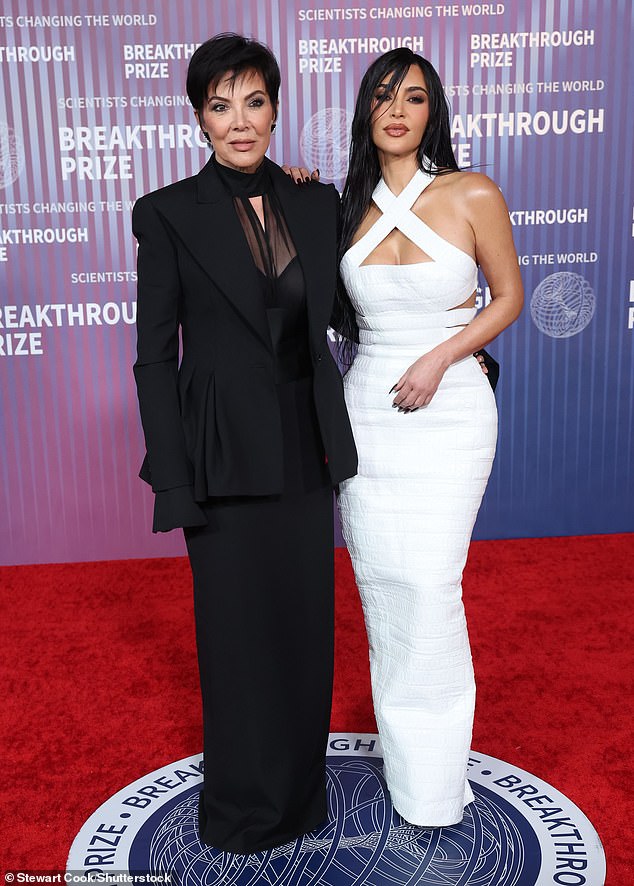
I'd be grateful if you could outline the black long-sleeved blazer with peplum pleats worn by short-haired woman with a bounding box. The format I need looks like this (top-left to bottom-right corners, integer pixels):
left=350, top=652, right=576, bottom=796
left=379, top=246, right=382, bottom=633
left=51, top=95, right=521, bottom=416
left=132, top=159, right=357, bottom=531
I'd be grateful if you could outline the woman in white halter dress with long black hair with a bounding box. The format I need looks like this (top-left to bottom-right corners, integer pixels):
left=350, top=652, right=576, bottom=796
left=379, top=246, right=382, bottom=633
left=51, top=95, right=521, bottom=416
left=337, top=49, right=523, bottom=827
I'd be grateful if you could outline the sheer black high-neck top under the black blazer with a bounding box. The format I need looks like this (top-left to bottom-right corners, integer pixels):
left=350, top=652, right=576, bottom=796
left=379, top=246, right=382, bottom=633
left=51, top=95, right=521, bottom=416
left=214, top=157, right=312, bottom=384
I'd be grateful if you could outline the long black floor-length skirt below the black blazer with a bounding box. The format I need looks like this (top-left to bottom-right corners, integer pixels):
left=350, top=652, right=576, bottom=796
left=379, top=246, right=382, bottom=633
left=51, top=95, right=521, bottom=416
left=185, top=379, right=334, bottom=853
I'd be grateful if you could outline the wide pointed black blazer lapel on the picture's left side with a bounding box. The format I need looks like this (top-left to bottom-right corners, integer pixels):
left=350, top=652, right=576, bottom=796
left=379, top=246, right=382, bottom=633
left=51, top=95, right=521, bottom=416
left=159, top=161, right=271, bottom=348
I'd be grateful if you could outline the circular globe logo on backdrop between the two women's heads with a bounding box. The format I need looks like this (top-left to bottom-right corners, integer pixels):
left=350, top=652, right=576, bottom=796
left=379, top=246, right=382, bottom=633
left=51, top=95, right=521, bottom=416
left=299, top=108, right=352, bottom=179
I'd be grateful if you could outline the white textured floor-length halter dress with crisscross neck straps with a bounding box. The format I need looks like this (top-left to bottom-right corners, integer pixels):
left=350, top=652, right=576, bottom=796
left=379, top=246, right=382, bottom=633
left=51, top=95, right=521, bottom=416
left=338, top=171, right=497, bottom=826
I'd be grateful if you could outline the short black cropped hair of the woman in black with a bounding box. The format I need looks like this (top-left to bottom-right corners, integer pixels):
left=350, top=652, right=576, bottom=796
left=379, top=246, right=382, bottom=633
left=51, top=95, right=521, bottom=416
left=187, top=33, right=281, bottom=111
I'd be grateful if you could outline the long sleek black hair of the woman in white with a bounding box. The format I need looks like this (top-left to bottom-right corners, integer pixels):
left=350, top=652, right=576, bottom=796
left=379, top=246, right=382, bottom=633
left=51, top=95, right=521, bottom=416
left=335, top=47, right=459, bottom=366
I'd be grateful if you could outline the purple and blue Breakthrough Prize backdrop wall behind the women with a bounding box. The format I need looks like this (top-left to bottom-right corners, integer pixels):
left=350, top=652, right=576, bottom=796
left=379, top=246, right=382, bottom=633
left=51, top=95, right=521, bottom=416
left=0, top=0, right=634, bottom=563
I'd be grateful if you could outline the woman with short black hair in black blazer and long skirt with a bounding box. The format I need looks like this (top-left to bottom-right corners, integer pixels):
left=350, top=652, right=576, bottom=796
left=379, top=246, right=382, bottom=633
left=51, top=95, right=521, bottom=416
left=133, top=34, right=357, bottom=853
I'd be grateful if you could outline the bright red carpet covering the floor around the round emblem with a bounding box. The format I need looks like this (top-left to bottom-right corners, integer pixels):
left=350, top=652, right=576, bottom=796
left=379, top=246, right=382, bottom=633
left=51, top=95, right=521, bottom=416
left=0, top=535, right=634, bottom=886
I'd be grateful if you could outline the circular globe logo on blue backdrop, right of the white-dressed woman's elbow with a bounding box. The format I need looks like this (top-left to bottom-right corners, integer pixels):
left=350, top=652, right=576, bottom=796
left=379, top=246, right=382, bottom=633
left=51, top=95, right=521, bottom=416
left=531, top=271, right=596, bottom=338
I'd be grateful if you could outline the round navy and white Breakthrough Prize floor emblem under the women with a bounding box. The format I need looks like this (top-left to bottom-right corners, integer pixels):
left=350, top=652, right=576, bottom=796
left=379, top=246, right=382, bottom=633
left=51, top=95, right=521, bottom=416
left=67, top=733, right=605, bottom=886
